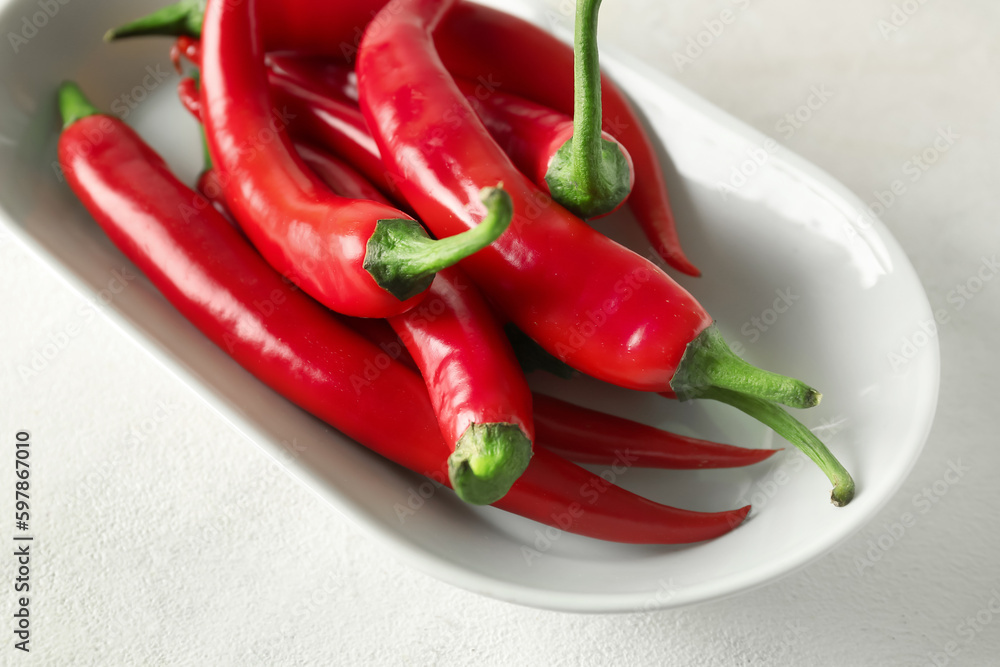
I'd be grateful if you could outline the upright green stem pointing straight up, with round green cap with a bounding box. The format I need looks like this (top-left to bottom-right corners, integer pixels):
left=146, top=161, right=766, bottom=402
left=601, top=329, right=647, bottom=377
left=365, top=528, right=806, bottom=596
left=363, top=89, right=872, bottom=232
left=545, top=0, right=632, bottom=219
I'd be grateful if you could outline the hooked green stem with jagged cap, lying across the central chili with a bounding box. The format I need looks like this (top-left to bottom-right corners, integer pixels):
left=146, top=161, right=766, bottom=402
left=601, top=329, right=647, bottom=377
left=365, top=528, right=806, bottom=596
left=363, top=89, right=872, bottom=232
left=364, top=185, right=514, bottom=301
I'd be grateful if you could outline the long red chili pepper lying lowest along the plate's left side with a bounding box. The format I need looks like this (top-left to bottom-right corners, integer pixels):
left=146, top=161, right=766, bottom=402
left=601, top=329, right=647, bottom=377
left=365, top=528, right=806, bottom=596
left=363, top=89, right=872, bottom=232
left=59, top=84, right=750, bottom=544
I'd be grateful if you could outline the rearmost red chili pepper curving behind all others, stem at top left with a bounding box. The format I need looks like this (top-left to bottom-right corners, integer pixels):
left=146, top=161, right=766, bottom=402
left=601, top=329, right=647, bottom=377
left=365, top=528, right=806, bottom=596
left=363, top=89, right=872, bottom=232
left=106, top=0, right=700, bottom=276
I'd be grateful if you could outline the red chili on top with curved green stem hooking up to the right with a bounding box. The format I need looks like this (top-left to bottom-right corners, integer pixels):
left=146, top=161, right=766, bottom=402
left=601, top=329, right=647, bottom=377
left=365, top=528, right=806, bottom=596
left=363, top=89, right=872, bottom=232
left=194, top=1, right=508, bottom=317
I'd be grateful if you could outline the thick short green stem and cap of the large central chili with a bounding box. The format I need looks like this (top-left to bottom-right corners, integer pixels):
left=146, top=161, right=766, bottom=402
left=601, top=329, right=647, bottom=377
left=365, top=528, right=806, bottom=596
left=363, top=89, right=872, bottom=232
left=670, top=322, right=823, bottom=408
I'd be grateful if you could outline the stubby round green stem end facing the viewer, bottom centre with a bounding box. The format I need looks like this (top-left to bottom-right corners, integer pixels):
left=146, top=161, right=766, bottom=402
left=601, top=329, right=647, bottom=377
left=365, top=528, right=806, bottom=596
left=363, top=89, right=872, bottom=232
left=448, top=423, right=531, bottom=505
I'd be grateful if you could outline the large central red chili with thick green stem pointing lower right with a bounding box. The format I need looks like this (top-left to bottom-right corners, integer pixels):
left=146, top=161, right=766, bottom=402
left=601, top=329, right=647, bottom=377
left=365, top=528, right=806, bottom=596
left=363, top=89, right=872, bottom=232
left=357, top=0, right=854, bottom=505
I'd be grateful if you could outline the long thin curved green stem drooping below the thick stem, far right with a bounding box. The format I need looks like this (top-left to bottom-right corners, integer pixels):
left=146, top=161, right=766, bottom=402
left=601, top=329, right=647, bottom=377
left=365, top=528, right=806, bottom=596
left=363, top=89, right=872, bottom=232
left=702, top=388, right=854, bottom=507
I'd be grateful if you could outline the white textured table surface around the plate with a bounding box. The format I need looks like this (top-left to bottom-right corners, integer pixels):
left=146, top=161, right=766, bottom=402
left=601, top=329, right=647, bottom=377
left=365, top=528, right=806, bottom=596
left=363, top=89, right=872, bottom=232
left=0, top=0, right=1000, bottom=665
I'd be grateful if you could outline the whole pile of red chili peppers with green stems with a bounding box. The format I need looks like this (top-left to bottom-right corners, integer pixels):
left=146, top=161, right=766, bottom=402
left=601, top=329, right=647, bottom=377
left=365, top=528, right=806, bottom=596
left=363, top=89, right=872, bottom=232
left=52, top=0, right=854, bottom=544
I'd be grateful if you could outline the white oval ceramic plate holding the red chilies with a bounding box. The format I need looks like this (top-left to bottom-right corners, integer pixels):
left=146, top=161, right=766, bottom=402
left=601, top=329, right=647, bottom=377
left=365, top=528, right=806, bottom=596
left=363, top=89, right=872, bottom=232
left=0, top=0, right=938, bottom=611
